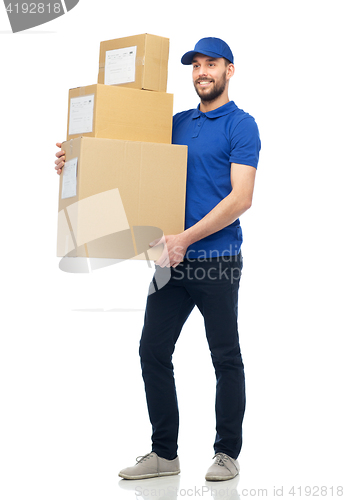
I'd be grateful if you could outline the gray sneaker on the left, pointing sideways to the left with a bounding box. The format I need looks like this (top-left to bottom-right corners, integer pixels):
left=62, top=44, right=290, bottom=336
left=119, top=451, right=180, bottom=479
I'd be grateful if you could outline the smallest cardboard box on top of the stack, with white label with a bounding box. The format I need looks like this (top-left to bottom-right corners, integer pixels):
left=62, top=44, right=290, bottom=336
left=98, top=33, right=169, bottom=92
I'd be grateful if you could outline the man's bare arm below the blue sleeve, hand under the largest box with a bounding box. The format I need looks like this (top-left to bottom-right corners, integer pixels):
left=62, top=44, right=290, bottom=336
left=152, top=163, right=256, bottom=267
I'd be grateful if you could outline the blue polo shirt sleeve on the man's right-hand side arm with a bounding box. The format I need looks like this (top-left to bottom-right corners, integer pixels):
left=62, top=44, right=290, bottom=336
left=229, top=115, right=261, bottom=168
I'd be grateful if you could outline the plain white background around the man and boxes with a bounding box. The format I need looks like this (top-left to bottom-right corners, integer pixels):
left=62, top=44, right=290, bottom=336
left=0, top=0, right=345, bottom=500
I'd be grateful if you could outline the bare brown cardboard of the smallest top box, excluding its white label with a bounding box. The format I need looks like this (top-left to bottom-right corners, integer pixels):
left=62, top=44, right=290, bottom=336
left=98, top=33, right=169, bottom=92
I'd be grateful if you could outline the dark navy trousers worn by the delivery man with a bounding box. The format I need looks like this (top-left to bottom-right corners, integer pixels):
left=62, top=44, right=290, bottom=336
left=139, top=253, right=245, bottom=460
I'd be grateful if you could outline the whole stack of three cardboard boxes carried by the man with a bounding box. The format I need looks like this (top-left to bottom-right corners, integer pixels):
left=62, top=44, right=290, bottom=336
left=58, top=34, right=187, bottom=260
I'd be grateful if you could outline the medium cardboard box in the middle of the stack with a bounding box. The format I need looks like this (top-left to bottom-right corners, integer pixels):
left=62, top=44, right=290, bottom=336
left=67, top=84, right=173, bottom=144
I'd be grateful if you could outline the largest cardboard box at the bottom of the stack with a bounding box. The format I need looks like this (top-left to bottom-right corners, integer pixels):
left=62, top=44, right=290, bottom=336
left=57, top=137, right=187, bottom=260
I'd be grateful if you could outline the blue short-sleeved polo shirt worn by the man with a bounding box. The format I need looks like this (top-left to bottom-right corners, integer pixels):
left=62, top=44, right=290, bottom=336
left=172, top=101, right=261, bottom=259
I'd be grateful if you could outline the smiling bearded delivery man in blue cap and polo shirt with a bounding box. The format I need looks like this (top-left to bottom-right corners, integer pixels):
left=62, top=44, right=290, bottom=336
left=55, top=37, right=261, bottom=481
